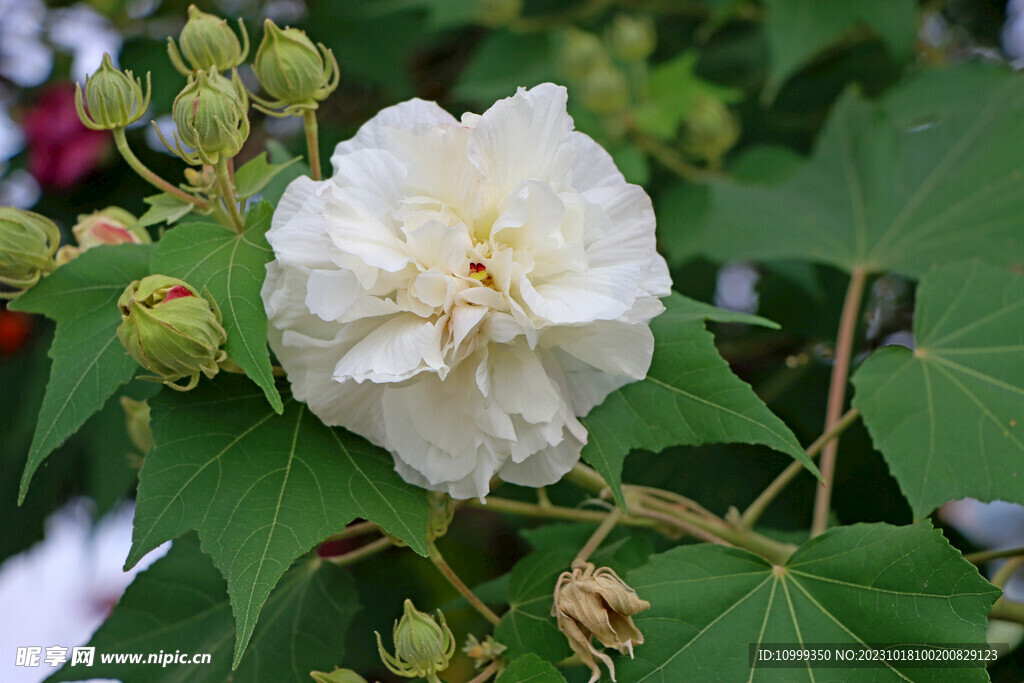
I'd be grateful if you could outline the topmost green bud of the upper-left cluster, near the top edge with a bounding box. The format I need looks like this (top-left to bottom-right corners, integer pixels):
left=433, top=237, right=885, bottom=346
left=167, top=5, right=249, bottom=76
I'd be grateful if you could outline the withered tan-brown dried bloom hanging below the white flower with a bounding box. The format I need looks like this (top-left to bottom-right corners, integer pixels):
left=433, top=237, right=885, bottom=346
left=551, top=562, right=650, bottom=683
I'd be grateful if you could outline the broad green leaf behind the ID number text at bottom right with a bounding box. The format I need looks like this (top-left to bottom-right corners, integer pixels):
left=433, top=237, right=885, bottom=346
left=612, top=521, right=999, bottom=683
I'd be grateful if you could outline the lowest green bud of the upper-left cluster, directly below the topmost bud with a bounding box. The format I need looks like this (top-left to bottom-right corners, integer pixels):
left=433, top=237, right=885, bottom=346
left=171, top=71, right=249, bottom=166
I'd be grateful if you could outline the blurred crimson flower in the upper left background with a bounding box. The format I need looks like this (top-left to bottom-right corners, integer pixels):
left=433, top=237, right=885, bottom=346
left=23, top=83, right=111, bottom=189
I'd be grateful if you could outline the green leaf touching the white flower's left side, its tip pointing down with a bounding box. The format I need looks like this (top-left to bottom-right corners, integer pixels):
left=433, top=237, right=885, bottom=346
left=153, top=202, right=283, bottom=413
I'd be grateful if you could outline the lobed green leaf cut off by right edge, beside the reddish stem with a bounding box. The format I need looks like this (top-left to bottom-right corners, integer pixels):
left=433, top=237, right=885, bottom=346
left=853, top=263, right=1024, bottom=517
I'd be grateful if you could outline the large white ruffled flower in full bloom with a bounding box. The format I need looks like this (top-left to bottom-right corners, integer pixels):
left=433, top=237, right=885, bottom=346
left=263, top=84, right=671, bottom=498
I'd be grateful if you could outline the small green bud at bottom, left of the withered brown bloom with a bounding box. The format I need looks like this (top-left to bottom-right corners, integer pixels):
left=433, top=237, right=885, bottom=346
left=377, top=600, right=455, bottom=678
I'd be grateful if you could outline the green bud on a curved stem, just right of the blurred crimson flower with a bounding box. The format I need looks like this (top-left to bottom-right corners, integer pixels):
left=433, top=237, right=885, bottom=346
left=75, top=54, right=152, bottom=130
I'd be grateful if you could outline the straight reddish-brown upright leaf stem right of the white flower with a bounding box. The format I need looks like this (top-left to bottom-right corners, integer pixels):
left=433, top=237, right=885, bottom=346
left=811, top=266, right=867, bottom=539
